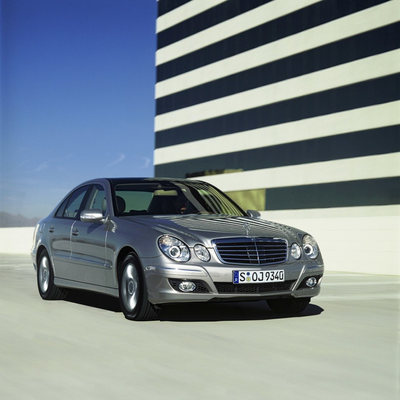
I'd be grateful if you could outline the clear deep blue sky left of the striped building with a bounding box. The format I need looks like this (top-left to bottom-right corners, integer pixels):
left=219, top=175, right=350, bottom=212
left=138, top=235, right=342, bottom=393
left=0, top=0, right=157, bottom=217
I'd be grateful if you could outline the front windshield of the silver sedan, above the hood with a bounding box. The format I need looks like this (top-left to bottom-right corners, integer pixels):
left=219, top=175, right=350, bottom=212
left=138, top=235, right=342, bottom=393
left=113, top=182, right=245, bottom=216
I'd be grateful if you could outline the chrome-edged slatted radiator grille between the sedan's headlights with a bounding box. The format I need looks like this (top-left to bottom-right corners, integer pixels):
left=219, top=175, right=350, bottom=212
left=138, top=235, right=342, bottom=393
left=213, top=238, right=287, bottom=265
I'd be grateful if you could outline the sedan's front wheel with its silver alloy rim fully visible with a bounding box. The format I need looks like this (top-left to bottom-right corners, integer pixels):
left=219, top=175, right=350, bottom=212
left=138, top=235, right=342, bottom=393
left=118, top=253, right=157, bottom=321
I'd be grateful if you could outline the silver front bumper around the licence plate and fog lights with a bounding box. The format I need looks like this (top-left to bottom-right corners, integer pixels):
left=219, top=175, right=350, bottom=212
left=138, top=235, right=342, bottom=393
left=142, top=259, right=324, bottom=304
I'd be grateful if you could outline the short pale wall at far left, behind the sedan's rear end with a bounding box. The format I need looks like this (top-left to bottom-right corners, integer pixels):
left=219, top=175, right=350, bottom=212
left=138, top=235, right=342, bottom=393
left=0, top=227, right=35, bottom=254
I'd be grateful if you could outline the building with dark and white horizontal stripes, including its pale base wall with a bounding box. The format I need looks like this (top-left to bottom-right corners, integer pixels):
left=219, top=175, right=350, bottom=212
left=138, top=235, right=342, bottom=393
left=154, top=0, right=400, bottom=274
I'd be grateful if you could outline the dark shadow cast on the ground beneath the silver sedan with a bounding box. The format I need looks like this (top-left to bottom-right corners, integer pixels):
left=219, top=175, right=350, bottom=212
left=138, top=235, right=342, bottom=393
left=66, top=290, right=324, bottom=322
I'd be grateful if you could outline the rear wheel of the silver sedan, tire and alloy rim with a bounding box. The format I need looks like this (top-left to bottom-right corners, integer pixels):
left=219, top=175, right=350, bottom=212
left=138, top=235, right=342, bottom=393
left=37, top=250, right=68, bottom=300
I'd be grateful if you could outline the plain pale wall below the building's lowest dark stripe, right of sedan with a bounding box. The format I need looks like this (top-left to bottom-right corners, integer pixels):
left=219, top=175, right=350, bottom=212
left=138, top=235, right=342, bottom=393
left=261, top=206, right=400, bottom=275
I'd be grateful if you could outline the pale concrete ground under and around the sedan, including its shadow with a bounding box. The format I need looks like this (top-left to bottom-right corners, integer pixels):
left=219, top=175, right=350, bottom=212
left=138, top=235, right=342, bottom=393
left=0, top=254, right=400, bottom=400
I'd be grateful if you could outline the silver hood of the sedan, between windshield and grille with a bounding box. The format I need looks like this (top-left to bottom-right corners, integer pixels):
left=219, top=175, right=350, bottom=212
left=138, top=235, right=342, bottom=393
left=122, top=215, right=304, bottom=246
